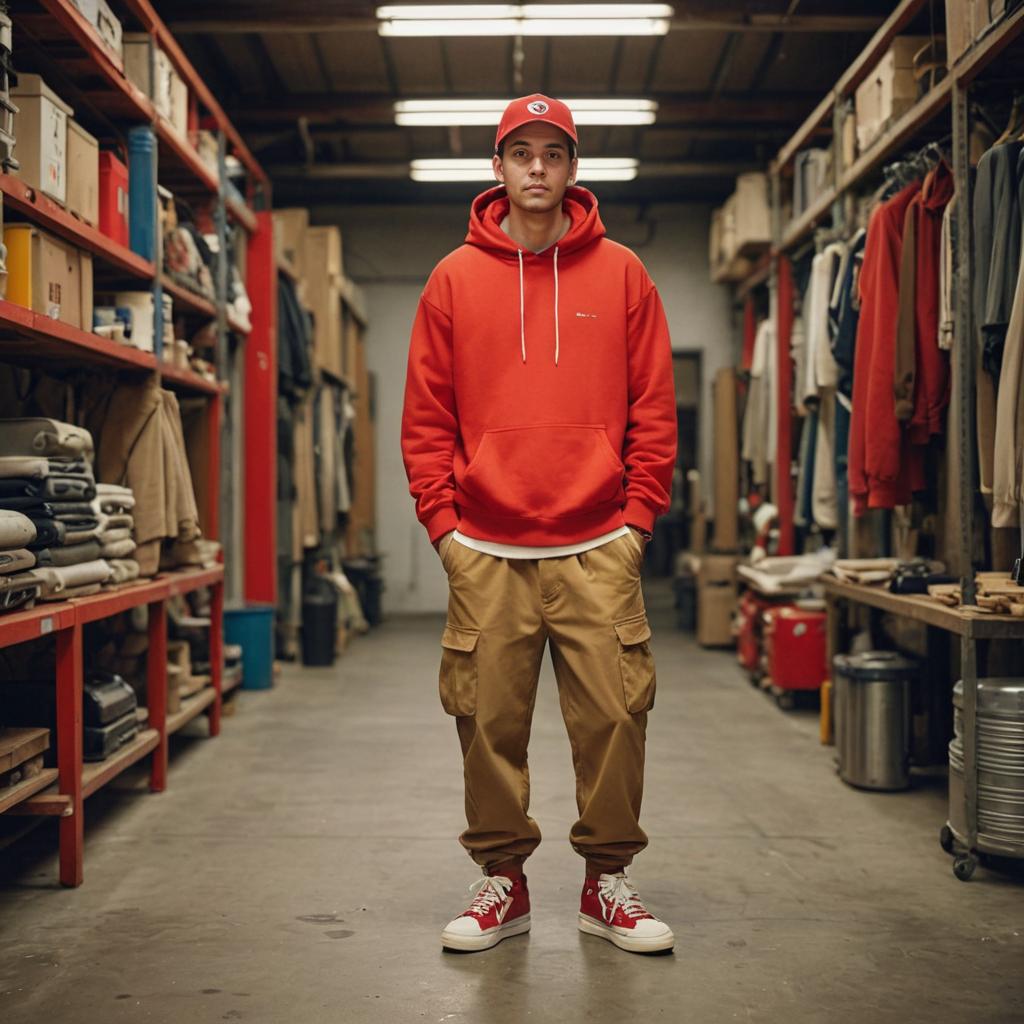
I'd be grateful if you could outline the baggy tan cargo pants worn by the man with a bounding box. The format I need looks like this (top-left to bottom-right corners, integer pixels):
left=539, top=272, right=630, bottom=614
left=440, top=532, right=655, bottom=874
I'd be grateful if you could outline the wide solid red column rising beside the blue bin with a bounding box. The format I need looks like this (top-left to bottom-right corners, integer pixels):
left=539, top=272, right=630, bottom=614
left=244, top=210, right=278, bottom=604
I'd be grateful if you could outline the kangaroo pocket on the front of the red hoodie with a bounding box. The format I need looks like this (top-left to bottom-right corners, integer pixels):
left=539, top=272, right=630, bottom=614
left=461, top=423, right=625, bottom=519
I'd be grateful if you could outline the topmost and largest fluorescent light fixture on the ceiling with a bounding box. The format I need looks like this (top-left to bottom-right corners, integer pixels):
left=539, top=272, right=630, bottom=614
left=377, top=3, right=673, bottom=36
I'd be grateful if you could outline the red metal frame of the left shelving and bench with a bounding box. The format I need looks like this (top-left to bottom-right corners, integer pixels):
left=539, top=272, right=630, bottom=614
left=0, top=0, right=276, bottom=886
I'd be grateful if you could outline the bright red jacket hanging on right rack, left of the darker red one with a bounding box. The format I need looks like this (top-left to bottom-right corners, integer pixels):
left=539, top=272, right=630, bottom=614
left=849, top=181, right=925, bottom=516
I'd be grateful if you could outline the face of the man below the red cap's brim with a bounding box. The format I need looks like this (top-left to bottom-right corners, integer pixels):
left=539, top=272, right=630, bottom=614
left=494, top=121, right=577, bottom=213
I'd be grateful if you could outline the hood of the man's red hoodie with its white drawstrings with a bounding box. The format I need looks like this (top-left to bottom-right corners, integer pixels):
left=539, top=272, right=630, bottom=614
left=466, top=185, right=604, bottom=367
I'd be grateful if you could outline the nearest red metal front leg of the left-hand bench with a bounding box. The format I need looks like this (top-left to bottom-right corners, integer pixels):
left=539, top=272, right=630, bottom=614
left=56, top=623, right=85, bottom=886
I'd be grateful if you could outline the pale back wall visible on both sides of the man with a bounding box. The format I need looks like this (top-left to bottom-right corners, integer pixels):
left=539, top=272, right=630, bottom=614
left=313, top=204, right=736, bottom=612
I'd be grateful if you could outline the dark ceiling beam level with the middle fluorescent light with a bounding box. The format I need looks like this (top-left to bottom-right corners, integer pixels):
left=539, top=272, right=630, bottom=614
left=230, top=93, right=811, bottom=127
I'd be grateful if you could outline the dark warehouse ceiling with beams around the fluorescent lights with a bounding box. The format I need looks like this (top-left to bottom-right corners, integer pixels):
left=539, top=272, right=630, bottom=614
left=156, top=0, right=905, bottom=205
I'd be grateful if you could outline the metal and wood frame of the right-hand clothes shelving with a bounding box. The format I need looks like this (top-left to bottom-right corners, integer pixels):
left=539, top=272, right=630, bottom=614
left=770, top=0, right=1024, bottom=881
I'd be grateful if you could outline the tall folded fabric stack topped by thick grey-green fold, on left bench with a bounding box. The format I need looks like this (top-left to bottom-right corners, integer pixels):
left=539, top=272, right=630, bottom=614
left=0, top=417, right=111, bottom=601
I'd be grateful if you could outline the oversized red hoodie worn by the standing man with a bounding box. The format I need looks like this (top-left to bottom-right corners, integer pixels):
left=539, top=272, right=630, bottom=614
left=401, top=186, right=676, bottom=546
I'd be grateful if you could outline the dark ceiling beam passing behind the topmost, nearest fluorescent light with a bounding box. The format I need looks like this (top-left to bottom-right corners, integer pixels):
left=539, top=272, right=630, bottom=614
left=169, top=12, right=883, bottom=36
